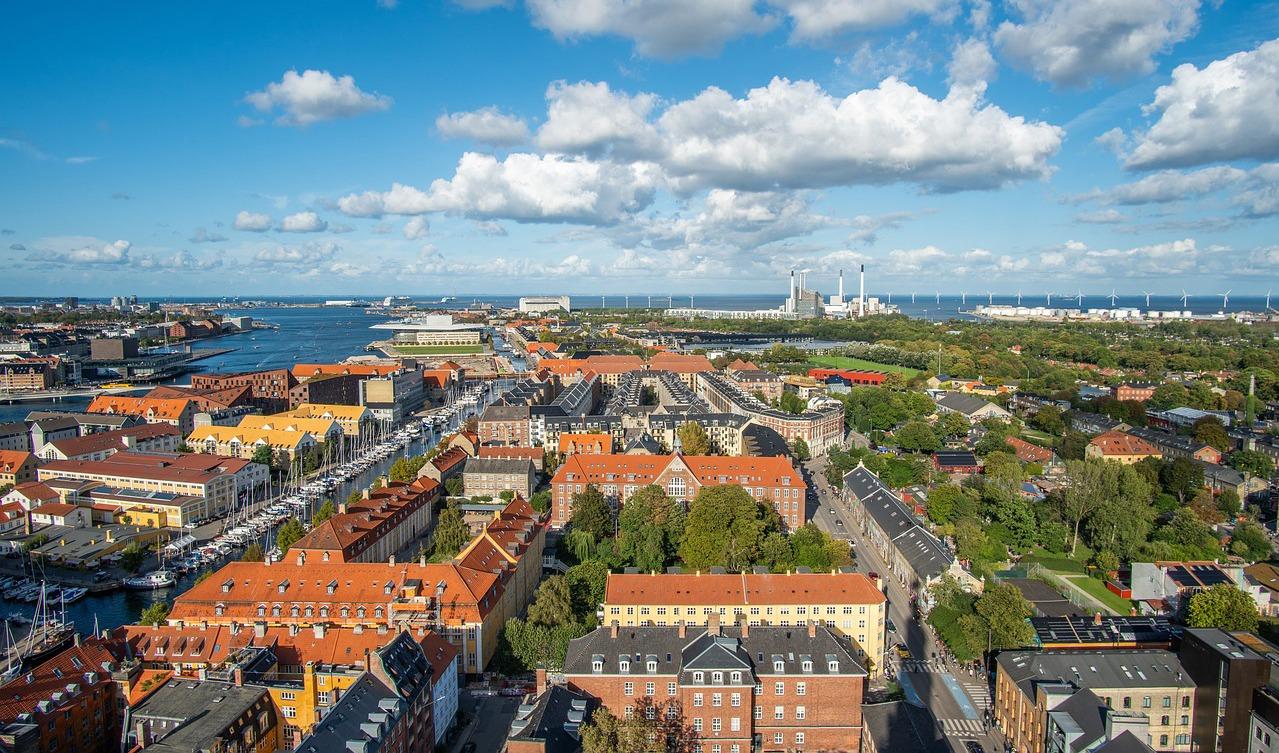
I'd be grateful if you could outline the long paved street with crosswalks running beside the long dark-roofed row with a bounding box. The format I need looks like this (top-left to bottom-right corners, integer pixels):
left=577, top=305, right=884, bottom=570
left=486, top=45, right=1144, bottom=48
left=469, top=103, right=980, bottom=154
left=806, top=458, right=1003, bottom=753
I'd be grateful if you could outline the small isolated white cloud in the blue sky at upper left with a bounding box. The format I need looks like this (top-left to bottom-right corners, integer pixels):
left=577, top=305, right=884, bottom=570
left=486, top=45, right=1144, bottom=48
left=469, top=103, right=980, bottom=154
left=244, top=70, right=391, bottom=127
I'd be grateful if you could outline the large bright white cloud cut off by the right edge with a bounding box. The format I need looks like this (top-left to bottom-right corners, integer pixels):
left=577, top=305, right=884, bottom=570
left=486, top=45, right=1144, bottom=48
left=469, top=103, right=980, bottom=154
left=1124, top=40, right=1279, bottom=169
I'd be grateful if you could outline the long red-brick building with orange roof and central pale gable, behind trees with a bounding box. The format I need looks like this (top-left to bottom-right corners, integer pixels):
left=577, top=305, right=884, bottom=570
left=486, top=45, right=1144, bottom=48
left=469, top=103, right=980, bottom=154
left=551, top=454, right=808, bottom=531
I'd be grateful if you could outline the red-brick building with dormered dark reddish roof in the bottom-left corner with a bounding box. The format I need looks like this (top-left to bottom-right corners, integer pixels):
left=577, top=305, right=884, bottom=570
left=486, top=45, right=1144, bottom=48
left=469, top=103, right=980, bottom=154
left=0, top=638, right=123, bottom=753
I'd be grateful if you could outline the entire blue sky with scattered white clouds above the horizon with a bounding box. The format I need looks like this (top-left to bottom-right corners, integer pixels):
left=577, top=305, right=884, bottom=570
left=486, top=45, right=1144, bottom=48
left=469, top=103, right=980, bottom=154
left=0, top=0, right=1279, bottom=295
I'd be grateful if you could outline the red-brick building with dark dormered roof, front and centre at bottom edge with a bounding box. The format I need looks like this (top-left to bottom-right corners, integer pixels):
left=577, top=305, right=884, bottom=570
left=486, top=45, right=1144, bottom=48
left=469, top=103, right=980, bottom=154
left=564, top=615, right=866, bottom=753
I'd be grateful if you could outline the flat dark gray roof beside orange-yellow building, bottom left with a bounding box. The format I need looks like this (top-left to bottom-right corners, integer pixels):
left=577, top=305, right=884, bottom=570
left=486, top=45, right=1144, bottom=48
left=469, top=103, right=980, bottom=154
left=130, top=679, right=266, bottom=753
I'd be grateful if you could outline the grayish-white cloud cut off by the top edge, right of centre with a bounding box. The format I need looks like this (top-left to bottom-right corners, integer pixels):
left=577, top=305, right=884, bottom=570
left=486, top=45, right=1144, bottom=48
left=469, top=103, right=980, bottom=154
left=995, top=0, right=1200, bottom=87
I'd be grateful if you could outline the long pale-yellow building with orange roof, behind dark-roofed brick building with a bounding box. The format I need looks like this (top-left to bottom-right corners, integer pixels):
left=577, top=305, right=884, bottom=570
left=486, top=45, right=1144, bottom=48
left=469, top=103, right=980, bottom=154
left=600, top=571, right=888, bottom=676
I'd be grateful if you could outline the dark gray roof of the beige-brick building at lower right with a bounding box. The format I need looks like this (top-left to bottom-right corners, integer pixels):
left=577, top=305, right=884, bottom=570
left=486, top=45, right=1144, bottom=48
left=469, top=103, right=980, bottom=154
left=995, top=648, right=1195, bottom=698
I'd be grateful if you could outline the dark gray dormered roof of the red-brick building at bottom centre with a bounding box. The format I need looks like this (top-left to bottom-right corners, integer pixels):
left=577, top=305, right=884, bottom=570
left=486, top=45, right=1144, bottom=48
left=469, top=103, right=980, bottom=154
left=564, top=626, right=866, bottom=681
